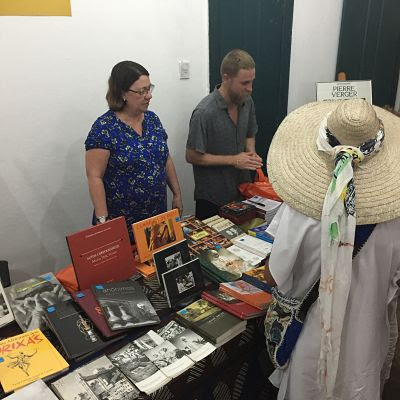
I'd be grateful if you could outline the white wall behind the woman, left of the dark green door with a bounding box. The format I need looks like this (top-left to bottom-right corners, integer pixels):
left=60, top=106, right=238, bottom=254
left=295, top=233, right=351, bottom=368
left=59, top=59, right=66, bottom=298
left=0, top=0, right=208, bottom=281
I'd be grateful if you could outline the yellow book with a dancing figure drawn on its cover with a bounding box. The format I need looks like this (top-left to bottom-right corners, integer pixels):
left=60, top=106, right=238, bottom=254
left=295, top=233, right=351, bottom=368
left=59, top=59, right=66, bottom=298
left=0, top=329, right=69, bottom=393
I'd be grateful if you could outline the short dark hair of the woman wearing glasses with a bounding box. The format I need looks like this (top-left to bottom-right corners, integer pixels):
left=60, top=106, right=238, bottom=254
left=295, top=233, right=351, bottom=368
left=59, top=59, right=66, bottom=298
left=106, top=61, right=149, bottom=111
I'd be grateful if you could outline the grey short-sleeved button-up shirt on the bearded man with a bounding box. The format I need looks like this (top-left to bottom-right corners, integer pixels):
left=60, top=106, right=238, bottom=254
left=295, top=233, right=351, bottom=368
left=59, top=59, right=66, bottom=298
left=186, top=87, right=258, bottom=206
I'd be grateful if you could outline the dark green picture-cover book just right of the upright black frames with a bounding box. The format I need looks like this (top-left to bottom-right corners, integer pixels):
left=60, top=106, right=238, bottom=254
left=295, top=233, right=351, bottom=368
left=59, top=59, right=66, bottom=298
left=199, top=247, right=252, bottom=282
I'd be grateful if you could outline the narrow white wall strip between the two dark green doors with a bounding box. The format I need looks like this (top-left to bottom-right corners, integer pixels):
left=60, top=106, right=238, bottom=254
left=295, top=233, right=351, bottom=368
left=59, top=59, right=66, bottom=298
left=288, top=0, right=343, bottom=112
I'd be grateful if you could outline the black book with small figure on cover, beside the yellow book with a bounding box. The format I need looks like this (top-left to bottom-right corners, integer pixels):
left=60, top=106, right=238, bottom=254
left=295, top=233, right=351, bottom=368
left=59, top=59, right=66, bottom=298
left=45, top=300, right=111, bottom=359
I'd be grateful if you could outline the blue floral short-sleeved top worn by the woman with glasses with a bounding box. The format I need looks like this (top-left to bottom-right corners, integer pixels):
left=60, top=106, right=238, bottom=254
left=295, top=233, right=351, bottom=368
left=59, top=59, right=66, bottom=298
left=85, top=110, right=169, bottom=240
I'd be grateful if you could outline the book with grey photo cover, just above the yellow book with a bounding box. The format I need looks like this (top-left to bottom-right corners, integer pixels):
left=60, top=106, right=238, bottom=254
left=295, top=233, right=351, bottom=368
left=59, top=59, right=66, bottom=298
left=4, top=272, right=71, bottom=332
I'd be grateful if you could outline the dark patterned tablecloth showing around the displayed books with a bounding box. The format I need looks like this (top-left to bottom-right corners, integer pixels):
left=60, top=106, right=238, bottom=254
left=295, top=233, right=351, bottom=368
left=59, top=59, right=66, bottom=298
left=0, top=280, right=276, bottom=400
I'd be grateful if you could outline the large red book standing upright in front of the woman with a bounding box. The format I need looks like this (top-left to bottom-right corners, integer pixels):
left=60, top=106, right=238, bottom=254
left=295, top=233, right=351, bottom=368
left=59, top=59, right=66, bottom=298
left=67, top=217, right=136, bottom=290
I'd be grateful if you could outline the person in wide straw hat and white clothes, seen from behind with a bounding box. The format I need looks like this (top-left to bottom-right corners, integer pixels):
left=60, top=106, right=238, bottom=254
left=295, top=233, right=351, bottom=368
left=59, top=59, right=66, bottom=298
left=267, top=99, right=400, bottom=400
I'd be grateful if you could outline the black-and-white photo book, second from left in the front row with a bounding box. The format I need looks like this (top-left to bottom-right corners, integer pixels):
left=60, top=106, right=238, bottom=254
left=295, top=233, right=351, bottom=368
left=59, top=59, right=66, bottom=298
left=108, top=343, right=171, bottom=394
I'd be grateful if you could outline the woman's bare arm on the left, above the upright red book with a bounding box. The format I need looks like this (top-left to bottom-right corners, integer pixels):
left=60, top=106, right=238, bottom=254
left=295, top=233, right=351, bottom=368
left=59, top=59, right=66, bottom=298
left=85, top=149, right=110, bottom=217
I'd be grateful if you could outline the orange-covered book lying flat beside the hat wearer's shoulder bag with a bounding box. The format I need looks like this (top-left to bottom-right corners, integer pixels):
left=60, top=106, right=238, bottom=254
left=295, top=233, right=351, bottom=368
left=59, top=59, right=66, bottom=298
left=219, top=280, right=271, bottom=310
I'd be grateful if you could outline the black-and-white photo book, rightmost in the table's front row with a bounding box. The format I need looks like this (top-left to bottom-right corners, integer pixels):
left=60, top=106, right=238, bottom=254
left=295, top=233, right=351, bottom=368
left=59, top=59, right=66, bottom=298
left=157, top=321, right=216, bottom=362
